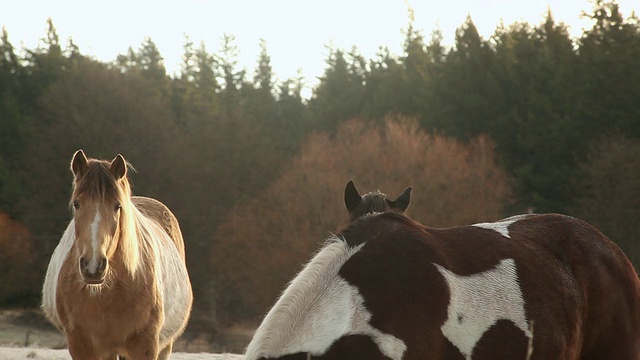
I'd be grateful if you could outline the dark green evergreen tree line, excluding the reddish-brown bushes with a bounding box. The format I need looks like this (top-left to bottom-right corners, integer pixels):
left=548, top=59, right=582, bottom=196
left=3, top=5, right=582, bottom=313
left=0, top=0, right=640, bottom=325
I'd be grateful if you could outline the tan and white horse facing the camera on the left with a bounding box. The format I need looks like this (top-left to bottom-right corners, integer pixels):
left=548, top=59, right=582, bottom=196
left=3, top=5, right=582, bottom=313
left=42, top=150, right=193, bottom=360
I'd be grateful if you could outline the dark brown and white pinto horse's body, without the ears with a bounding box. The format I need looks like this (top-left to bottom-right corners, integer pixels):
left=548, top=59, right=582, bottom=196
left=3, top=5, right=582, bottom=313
left=245, top=211, right=640, bottom=360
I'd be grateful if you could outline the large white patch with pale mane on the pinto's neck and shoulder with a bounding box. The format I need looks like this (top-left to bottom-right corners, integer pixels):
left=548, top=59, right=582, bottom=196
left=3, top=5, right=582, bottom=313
left=245, top=238, right=407, bottom=360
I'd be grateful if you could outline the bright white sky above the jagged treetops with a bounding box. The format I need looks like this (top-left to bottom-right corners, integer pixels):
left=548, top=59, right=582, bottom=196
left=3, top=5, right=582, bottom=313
left=0, top=0, right=640, bottom=95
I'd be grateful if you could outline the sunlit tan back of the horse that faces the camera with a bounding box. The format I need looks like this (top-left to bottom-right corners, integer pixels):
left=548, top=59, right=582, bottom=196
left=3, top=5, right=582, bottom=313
left=131, top=196, right=186, bottom=261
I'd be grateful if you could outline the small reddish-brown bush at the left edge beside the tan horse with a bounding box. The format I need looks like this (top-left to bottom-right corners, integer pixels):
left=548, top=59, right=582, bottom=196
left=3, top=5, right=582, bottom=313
left=0, top=212, right=40, bottom=306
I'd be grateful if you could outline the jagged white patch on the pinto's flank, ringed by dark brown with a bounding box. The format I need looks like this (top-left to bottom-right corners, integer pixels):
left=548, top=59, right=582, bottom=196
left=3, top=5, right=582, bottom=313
left=434, top=259, right=533, bottom=360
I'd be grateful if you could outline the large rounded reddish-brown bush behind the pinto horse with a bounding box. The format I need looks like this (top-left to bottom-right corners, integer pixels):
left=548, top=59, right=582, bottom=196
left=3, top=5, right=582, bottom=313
left=213, top=117, right=511, bottom=322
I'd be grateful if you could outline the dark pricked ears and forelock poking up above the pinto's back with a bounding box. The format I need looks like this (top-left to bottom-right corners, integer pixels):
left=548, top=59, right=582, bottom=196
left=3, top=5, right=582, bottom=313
left=344, top=180, right=411, bottom=222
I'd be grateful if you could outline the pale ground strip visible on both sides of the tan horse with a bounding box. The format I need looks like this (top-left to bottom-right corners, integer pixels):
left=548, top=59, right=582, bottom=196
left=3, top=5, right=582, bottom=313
left=0, top=310, right=245, bottom=360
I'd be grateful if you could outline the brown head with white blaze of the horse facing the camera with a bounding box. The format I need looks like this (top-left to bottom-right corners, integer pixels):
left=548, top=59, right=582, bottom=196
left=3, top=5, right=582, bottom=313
left=71, top=150, right=131, bottom=285
